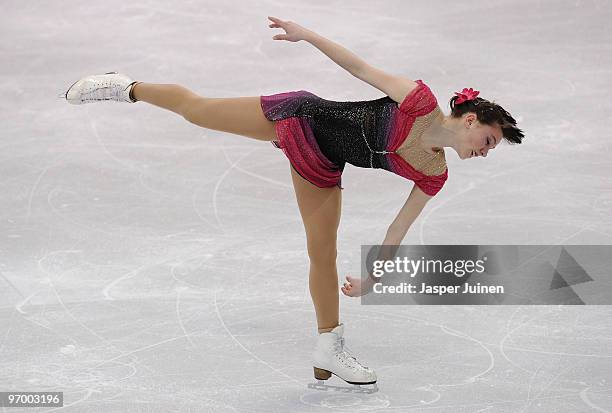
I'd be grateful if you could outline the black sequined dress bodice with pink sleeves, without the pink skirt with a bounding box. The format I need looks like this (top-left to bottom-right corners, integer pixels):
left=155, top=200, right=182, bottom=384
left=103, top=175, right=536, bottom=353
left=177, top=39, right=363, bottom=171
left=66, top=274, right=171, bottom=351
left=265, top=80, right=448, bottom=195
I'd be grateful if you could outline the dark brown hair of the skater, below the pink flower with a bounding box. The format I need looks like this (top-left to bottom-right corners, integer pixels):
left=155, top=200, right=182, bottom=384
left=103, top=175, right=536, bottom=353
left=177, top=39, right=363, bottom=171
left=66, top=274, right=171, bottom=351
left=449, top=96, right=525, bottom=144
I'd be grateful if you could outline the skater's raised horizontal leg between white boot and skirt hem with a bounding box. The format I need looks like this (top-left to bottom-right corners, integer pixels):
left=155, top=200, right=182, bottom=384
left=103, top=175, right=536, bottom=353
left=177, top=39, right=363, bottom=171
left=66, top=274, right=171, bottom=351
left=132, top=83, right=276, bottom=141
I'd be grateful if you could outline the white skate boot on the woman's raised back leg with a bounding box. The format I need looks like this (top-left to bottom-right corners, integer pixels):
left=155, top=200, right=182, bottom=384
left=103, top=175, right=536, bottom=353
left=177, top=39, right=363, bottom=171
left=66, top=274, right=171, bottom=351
left=59, top=72, right=139, bottom=105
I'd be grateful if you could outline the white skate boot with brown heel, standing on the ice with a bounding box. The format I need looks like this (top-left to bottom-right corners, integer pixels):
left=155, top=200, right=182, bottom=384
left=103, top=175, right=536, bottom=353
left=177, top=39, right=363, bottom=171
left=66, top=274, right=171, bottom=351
left=312, top=323, right=376, bottom=384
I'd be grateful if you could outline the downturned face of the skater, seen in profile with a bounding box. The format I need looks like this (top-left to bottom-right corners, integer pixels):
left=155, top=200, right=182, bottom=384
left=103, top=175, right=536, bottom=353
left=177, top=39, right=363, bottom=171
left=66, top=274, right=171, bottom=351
left=458, top=113, right=503, bottom=159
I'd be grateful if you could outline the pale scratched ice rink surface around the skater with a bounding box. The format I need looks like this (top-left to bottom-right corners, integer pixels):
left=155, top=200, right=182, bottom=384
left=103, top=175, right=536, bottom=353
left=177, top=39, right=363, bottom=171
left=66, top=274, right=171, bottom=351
left=0, top=0, right=612, bottom=413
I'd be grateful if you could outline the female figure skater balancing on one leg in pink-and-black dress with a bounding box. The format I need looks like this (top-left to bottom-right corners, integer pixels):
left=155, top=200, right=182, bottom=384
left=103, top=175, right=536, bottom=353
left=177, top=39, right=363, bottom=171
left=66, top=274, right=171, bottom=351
left=62, top=17, right=524, bottom=384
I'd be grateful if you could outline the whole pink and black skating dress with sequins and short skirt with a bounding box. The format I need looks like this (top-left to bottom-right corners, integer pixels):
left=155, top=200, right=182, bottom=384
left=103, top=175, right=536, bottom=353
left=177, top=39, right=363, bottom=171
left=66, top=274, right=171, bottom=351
left=261, top=80, right=448, bottom=195
